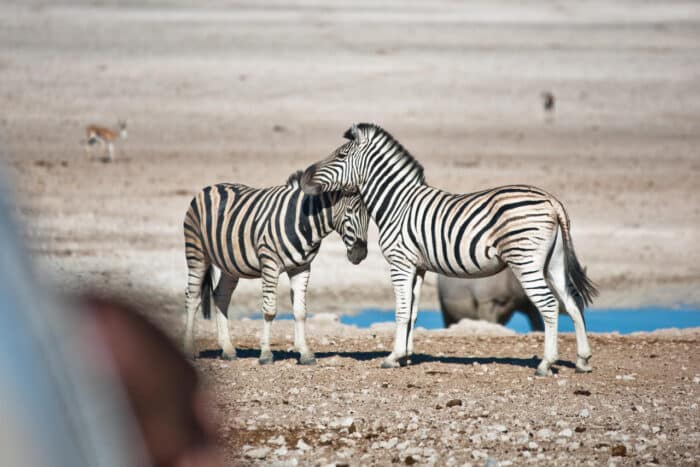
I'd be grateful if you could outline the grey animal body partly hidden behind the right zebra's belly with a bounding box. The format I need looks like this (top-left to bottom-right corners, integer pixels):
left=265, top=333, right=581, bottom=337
left=438, top=268, right=544, bottom=331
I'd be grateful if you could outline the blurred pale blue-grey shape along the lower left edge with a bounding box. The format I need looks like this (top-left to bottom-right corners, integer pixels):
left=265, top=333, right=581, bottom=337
left=0, top=169, right=147, bottom=467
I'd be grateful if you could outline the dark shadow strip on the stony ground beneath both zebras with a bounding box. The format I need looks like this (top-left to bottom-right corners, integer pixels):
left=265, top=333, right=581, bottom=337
left=199, top=349, right=576, bottom=373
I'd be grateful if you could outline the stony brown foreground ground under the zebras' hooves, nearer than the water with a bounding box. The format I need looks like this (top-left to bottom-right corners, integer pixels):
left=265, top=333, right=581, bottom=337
left=196, top=321, right=700, bottom=466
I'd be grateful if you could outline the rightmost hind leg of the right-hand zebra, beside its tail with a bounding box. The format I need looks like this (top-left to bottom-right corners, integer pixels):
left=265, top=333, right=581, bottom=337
left=547, top=235, right=593, bottom=373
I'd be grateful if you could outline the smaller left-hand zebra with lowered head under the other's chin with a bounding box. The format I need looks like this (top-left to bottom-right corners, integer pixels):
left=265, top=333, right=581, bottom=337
left=184, top=171, right=369, bottom=365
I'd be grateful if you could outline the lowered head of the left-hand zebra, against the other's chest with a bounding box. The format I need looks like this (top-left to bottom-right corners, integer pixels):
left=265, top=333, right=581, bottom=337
left=333, top=192, right=369, bottom=264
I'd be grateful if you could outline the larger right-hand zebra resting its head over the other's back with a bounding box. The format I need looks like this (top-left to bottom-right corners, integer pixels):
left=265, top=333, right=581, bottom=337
left=302, top=123, right=597, bottom=376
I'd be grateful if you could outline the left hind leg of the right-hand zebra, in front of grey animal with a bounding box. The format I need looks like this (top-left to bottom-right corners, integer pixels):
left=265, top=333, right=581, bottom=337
left=510, top=264, right=559, bottom=376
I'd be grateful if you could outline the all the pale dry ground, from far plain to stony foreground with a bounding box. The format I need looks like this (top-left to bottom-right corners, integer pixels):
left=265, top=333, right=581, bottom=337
left=0, top=0, right=700, bottom=465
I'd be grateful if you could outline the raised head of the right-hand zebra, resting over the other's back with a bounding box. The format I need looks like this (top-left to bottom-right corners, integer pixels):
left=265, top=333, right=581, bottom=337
left=301, top=123, right=376, bottom=194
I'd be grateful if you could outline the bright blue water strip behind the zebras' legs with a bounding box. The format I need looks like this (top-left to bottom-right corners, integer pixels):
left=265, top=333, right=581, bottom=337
left=340, top=308, right=700, bottom=334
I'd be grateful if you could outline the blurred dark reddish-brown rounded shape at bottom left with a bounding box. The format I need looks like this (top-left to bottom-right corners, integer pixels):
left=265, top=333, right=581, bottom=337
left=85, top=297, right=221, bottom=467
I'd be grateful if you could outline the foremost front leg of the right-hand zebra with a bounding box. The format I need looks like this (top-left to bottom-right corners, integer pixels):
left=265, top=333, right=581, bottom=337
left=382, top=264, right=416, bottom=368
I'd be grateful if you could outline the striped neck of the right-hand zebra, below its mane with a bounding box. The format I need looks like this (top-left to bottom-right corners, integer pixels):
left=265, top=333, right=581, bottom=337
left=360, top=154, right=424, bottom=228
